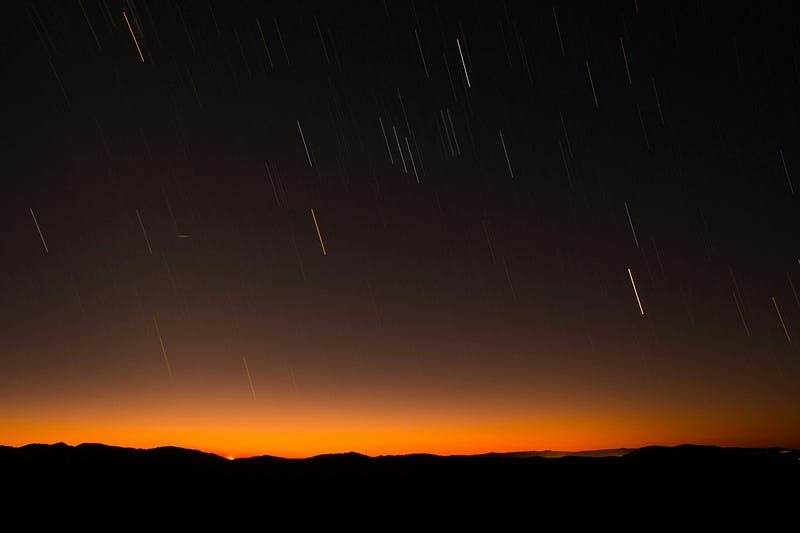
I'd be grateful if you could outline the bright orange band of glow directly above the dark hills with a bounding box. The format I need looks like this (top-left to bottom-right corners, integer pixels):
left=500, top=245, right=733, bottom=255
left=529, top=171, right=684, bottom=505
left=2, top=400, right=797, bottom=458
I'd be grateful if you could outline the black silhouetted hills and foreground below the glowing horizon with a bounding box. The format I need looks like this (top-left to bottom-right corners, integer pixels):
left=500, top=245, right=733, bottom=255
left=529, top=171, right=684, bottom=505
left=0, top=444, right=800, bottom=531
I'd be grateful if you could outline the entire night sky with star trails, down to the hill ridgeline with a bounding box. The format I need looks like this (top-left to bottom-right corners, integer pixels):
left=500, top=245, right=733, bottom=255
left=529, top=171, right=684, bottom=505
left=0, top=0, right=800, bottom=457
